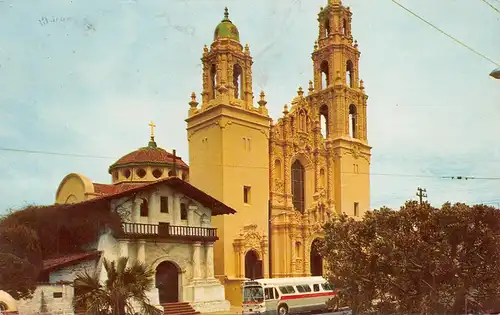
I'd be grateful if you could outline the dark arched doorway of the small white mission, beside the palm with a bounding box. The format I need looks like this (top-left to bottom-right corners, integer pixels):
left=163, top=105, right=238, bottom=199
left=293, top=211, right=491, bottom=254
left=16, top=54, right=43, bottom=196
left=155, top=261, right=180, bottom=304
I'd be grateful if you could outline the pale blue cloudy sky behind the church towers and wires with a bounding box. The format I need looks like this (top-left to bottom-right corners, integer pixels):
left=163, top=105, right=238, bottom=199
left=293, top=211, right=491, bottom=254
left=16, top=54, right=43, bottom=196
left=0, top=0, right=500, bottom=212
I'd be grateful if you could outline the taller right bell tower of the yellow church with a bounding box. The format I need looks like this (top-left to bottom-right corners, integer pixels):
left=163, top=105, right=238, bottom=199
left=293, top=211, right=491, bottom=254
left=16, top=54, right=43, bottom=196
left=308, top=0, right=371, bottom=217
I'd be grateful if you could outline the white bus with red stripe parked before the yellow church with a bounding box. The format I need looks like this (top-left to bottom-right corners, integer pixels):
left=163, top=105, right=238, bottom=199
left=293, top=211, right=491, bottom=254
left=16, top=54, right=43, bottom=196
left=243, top=277, right=336, bottom=315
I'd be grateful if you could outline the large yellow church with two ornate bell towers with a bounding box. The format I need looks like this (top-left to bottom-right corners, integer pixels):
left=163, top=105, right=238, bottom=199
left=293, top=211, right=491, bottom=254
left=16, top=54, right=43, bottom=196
left=186, top=0, right=371, bottom=304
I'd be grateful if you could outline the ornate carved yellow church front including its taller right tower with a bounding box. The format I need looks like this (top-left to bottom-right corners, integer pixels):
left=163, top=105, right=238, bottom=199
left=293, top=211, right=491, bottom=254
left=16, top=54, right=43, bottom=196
left=270, top=1, right=371, bottom=276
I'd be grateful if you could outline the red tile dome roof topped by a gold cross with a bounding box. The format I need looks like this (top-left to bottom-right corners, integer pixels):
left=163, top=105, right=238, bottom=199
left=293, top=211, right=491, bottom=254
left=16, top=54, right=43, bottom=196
left=109, top=146, right=188, bottom=173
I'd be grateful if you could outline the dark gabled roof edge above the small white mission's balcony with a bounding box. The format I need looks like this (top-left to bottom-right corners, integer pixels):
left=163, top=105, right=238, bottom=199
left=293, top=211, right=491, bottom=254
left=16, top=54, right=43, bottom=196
left=70, top=177, right=236, bottom=215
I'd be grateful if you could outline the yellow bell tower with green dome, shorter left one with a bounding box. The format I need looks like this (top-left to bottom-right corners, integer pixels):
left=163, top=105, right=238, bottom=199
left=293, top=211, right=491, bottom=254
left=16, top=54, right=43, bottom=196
left=186, top=8, right=271, bottom=305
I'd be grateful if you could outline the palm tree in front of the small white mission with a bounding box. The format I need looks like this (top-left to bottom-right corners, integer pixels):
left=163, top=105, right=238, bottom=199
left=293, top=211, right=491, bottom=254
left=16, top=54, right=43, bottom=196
left=73, top=257, right=163, bottom=315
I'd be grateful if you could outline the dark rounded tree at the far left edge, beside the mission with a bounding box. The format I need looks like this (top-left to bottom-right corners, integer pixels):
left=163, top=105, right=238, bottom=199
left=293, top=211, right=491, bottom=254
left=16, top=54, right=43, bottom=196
left=0, top=221, right=42, bottom=299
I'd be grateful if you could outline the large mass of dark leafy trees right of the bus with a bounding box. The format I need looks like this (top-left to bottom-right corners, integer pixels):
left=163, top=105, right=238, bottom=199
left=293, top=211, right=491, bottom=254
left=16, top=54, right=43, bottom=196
left=322, top=201, right=500, bottom=314
